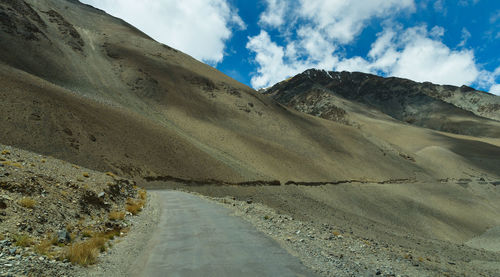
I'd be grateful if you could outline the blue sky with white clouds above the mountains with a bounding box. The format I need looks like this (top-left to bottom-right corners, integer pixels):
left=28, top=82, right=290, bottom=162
left=82, top=0, right=500, bottom=95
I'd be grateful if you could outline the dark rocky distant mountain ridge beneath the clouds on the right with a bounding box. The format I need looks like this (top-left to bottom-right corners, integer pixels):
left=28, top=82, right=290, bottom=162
left=264, top=69, right=500, bottom=137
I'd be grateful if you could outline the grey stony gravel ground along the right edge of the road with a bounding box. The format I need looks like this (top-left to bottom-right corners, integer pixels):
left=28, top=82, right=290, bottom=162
left=188, top=191, right=498, bottom=276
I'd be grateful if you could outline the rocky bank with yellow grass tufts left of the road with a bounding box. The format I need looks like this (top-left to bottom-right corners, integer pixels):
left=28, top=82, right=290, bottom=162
left=0, top=145, right=146, bottom=276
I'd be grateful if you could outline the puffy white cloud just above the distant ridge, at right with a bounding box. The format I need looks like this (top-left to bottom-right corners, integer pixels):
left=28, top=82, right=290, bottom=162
left=335, top=26, right=479, bottom=86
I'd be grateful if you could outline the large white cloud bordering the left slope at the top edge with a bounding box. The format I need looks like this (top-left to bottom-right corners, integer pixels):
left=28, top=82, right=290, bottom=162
left=82, top=0, right=246, bottom=64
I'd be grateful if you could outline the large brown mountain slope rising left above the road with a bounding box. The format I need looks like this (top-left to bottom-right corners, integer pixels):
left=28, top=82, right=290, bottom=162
left=0, top=0, right=430, bottom=181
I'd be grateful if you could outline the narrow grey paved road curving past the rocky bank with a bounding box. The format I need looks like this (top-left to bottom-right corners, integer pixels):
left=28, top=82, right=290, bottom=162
left=129, top=191, right=315, bottom=277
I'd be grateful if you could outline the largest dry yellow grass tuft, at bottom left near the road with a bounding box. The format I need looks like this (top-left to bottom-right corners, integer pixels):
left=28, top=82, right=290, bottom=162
left=64, top=236, right=107, bottom=266
